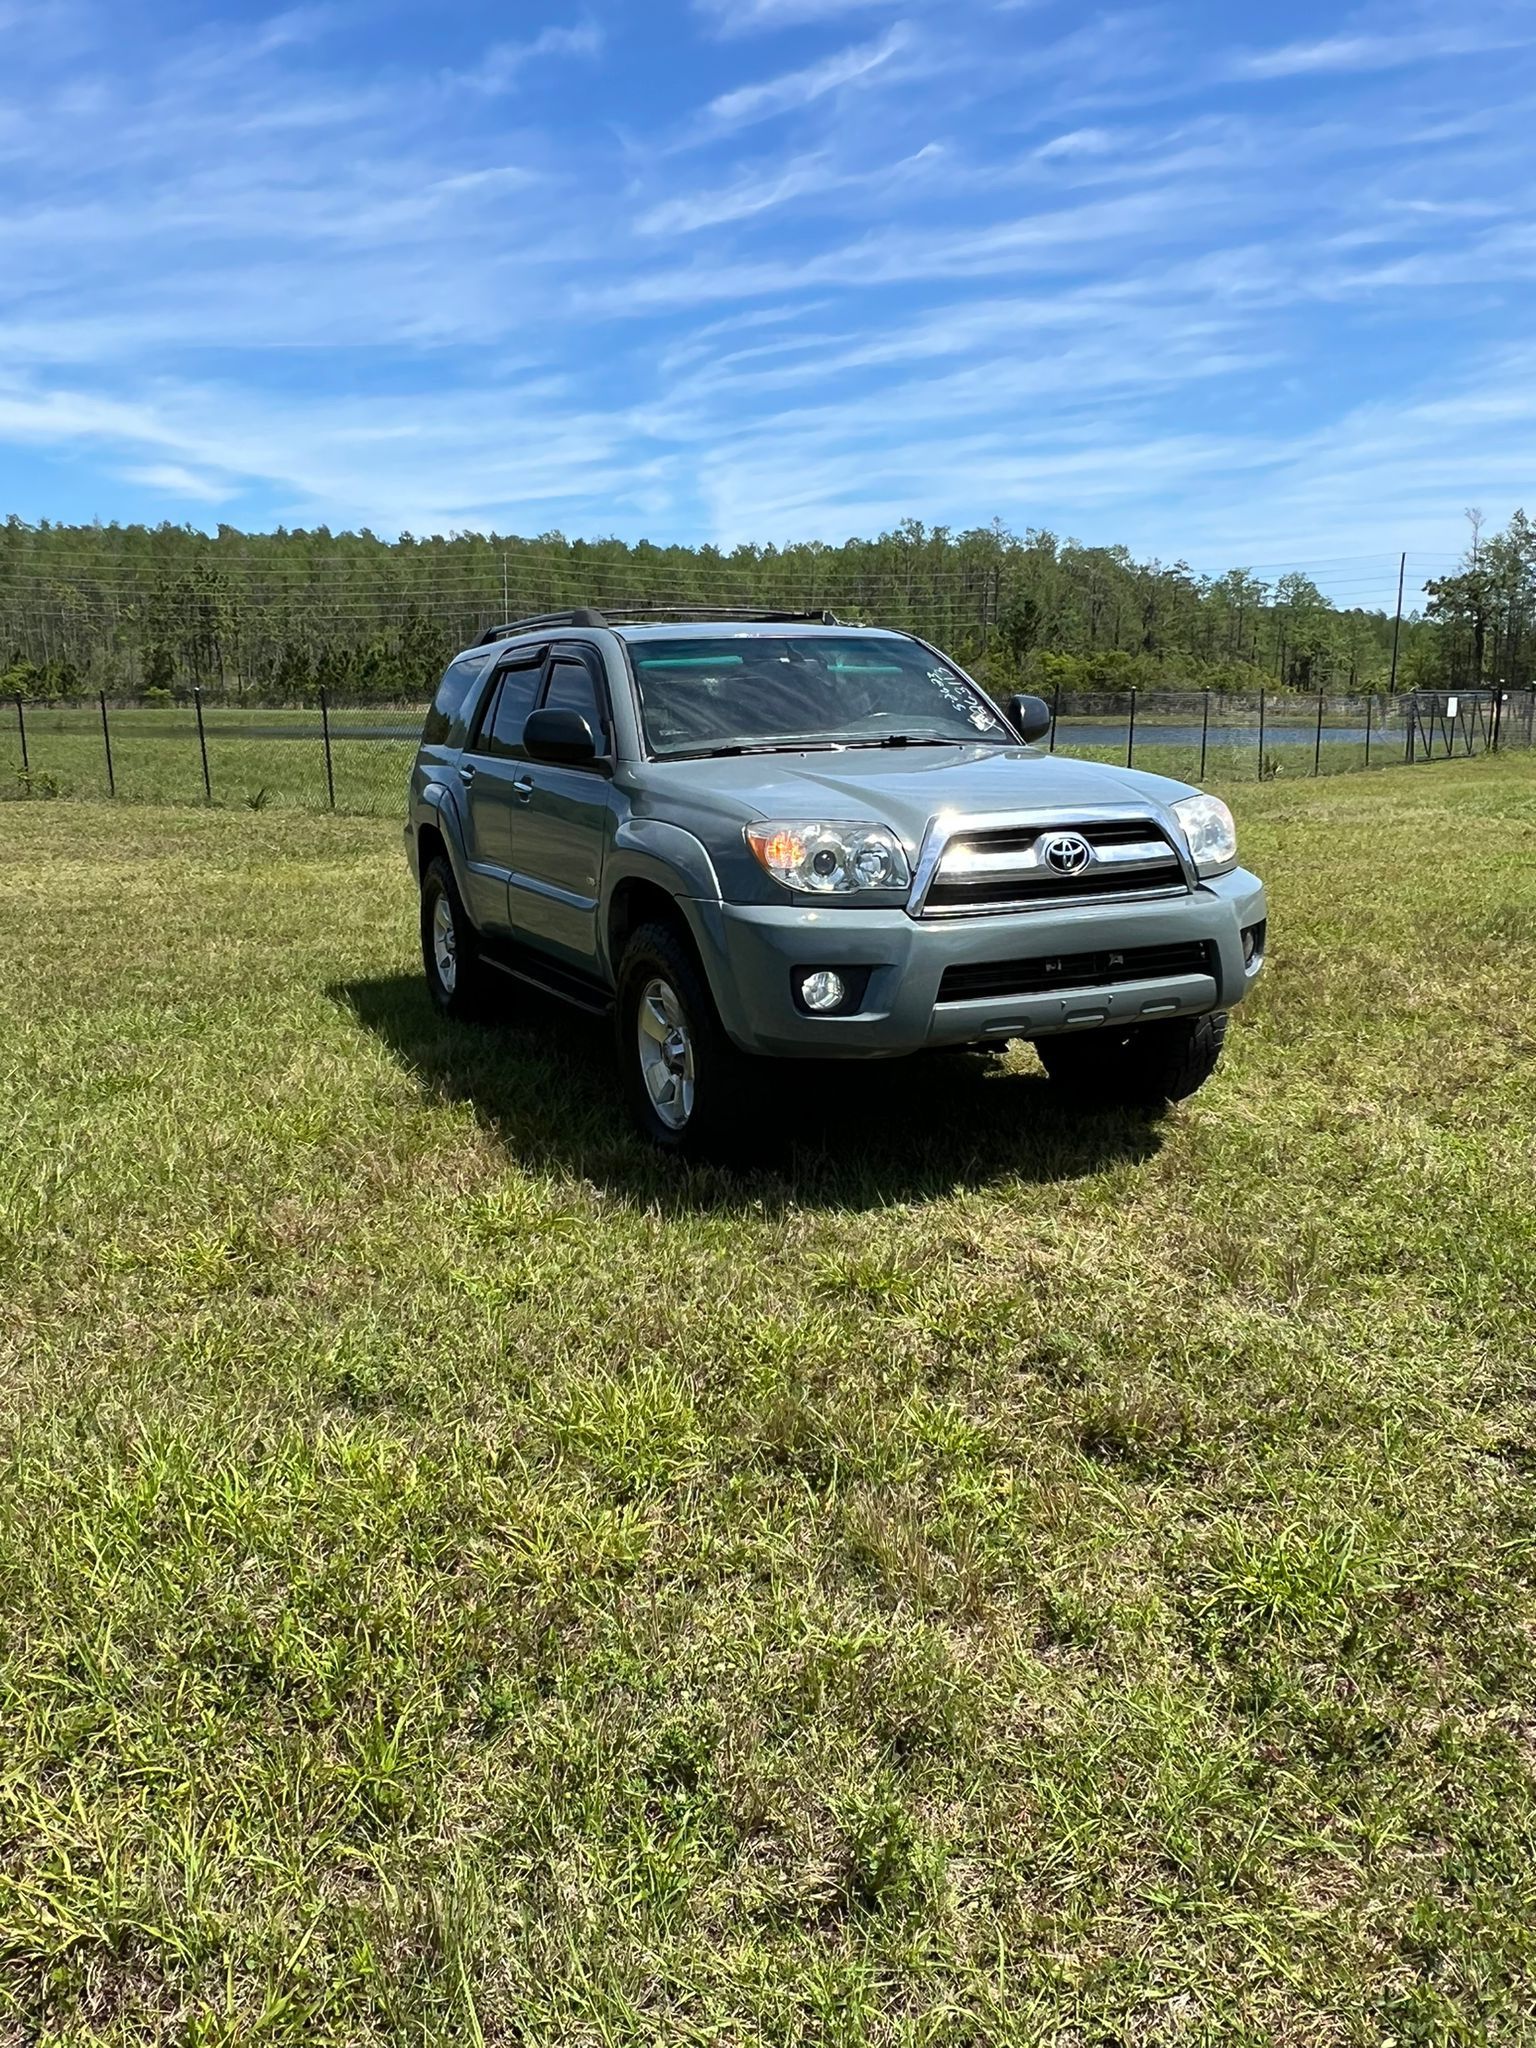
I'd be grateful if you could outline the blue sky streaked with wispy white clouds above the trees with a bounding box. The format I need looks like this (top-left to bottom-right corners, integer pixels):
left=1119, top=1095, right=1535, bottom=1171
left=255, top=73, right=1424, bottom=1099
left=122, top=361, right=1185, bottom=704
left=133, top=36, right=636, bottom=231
left=0, top=0, right=1536, bottom=590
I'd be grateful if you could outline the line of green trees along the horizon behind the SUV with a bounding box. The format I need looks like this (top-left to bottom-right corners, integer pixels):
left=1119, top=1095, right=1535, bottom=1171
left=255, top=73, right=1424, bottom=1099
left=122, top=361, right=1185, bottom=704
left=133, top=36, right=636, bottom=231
left=0, top=512, right=1536, bottom=702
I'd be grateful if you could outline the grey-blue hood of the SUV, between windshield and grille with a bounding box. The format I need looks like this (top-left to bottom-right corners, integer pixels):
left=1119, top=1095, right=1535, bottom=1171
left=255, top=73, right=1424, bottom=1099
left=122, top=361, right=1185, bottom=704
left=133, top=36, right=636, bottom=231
left=647, top=745, right=1192, bottom=848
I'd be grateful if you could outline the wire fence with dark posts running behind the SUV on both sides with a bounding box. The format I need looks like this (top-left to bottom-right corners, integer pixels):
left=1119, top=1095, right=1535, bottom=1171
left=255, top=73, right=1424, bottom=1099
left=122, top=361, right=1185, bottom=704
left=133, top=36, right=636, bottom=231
left=0, top=688, right=1536, bottom=817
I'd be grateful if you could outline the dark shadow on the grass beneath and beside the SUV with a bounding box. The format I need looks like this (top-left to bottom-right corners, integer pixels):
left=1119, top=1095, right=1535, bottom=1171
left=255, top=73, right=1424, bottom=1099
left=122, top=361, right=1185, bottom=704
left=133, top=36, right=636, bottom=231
left=328, top=975, right=1161, bottom=1210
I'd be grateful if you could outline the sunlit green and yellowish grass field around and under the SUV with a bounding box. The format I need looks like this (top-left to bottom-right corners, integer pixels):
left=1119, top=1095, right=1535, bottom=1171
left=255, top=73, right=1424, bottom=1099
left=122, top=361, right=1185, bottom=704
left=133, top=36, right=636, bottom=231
left=0, top=760, right=1536, bottom=2048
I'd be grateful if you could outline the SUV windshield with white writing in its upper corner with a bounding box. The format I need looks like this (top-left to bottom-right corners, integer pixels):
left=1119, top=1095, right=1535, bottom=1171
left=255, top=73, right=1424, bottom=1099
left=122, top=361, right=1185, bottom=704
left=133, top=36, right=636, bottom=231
left=629, top=633, right=1014, bottom=754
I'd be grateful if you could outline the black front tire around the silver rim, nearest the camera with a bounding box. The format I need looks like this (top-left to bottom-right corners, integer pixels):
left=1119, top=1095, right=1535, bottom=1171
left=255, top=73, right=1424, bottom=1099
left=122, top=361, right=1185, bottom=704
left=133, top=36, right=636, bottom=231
left=614, top=924, right=752, bottom=1157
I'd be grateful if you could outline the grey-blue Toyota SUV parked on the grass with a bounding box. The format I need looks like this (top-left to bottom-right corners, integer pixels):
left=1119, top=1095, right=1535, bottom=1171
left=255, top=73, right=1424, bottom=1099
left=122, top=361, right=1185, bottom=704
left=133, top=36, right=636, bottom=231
left=406, top=610, right=1266, bottom=1151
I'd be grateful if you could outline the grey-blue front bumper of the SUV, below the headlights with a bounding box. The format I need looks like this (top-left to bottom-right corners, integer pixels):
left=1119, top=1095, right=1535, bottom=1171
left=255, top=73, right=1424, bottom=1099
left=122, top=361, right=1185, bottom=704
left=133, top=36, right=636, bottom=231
left=690, top=868, right=1268, bottom=1059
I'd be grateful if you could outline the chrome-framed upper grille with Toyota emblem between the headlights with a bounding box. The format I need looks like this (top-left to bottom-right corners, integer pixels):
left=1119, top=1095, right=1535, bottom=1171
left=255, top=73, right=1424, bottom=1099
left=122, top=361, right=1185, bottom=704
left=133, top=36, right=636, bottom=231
left=922, top=817, right=1188, bottom=918
